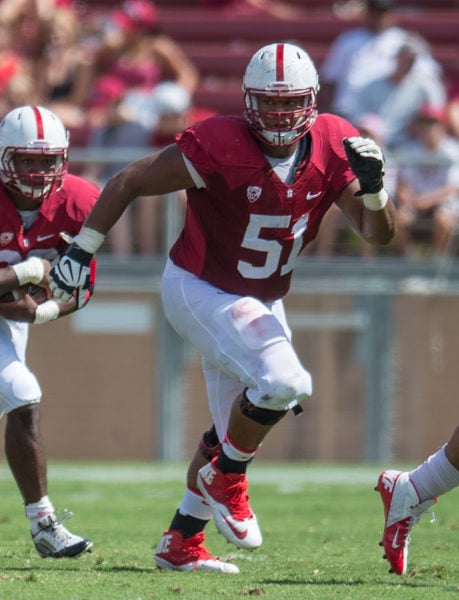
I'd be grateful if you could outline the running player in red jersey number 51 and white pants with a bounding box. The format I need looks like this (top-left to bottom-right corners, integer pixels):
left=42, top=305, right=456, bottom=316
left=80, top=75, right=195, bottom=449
left=51, top=43, right=395, bottom=573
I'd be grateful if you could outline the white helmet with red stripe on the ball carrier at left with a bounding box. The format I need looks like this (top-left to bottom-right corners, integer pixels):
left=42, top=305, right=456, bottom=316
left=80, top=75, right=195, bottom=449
left=0, top=106, right=69, bottom=200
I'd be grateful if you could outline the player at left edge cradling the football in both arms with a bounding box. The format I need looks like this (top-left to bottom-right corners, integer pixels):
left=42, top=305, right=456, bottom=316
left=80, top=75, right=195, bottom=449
left=0, top=106, right=98, bottom=558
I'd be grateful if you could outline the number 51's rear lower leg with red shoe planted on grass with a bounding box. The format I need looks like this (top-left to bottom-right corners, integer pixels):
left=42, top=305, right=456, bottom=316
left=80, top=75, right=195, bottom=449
left=155, top=426, right=239, bottom=573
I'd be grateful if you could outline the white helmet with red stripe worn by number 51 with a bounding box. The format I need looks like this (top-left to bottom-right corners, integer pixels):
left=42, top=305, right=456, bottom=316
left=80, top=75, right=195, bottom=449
left=242, top=43, right=319, bottom=146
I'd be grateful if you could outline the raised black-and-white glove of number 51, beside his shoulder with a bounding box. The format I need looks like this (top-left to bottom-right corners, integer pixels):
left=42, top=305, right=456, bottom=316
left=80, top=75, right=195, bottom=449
left=343, top=137, right=384, bottom=196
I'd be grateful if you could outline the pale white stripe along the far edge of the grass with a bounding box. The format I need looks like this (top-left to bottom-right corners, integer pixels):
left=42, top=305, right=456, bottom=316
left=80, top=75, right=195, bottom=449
left=0, top=463, right=383, bottom=491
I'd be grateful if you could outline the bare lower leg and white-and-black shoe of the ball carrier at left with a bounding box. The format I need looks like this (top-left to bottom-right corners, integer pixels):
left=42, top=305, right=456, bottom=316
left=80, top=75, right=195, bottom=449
left=5, top=403, right=92, bottom=558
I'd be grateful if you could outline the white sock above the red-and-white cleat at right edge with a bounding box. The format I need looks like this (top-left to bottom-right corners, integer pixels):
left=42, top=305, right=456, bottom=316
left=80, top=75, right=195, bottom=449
left=408, top=444, right=459, bottom=502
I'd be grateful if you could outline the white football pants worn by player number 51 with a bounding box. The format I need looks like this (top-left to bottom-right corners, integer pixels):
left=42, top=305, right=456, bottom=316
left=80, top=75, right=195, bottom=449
left=161, top=260, right=312, bottom=440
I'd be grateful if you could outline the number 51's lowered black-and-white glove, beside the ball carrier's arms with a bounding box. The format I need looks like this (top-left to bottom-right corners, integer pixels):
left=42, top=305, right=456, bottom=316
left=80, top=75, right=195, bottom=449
left=49, top=243, right=92, bottom=307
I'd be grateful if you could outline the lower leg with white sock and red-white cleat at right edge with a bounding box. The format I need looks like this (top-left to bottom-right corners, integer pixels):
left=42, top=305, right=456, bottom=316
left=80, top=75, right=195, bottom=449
left=376, top=429, right=459, bottom=575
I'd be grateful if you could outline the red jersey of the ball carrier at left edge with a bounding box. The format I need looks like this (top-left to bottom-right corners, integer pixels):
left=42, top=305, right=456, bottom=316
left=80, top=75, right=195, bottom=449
left=0, top=174, right=99, bottom=290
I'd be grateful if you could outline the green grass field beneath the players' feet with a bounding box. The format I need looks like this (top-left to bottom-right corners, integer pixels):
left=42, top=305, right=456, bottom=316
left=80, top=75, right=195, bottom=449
left=0, top=463, right=459, bottom=600
